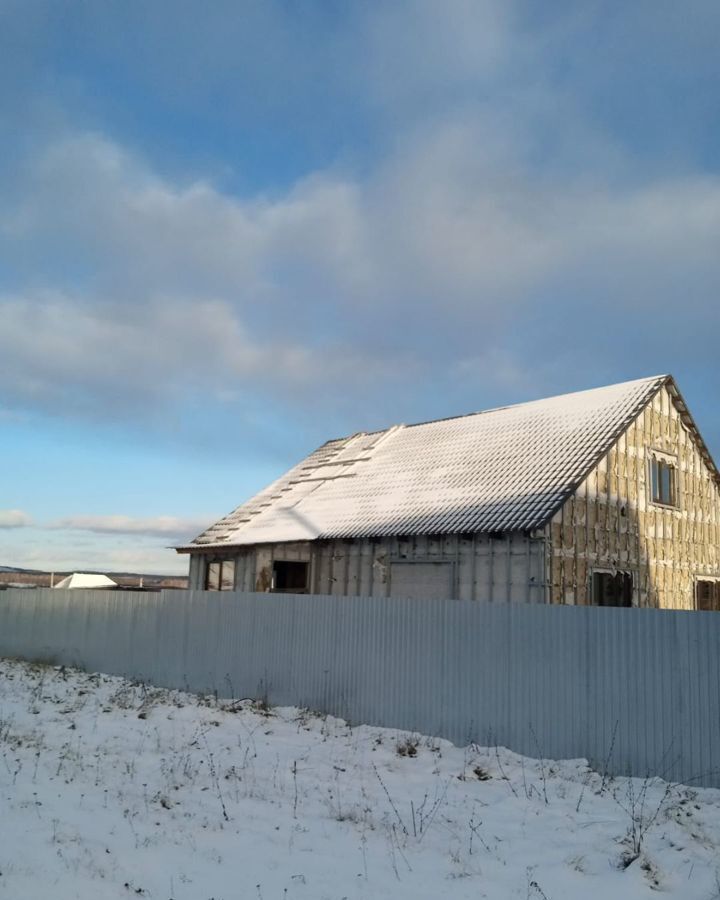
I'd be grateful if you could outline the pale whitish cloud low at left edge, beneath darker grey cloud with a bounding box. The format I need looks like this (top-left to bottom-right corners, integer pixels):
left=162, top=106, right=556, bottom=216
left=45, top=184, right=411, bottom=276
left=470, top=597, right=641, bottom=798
left=0, top=292, right=300, bottom=415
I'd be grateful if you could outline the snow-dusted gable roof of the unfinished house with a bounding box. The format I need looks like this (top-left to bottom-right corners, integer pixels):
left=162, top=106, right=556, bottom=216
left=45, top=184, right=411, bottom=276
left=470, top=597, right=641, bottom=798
left=177, top=375, right=720, bottom=552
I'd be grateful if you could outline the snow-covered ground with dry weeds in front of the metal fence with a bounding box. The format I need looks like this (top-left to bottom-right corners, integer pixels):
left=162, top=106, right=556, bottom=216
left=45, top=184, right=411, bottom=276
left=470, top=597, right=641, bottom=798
left=0, top=661, right=720, bottom=900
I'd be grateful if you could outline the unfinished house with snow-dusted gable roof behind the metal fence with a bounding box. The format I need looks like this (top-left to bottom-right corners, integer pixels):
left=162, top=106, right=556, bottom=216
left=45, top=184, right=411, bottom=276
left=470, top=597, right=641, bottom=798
left=176, top=375, right=720, bottom=609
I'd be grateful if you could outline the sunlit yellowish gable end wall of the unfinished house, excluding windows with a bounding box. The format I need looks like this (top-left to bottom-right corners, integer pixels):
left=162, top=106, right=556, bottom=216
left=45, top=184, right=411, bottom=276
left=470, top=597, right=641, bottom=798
left=546, top=386, right=720, bottom=609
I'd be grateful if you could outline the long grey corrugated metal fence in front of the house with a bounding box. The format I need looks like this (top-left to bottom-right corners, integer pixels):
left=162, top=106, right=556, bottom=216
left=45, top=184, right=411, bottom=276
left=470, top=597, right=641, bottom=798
left=0, top=590, right=720, bottom=787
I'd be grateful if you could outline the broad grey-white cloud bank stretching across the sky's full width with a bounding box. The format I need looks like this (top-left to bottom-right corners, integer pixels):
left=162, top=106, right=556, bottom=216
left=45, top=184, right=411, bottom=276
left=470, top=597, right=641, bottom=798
left=0, top=109, right=720, bottom=428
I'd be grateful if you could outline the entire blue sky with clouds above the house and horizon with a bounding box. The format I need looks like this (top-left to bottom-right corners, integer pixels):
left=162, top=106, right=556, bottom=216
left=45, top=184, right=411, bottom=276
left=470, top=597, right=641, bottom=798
left=0, top=0, right=720, bottom=572
